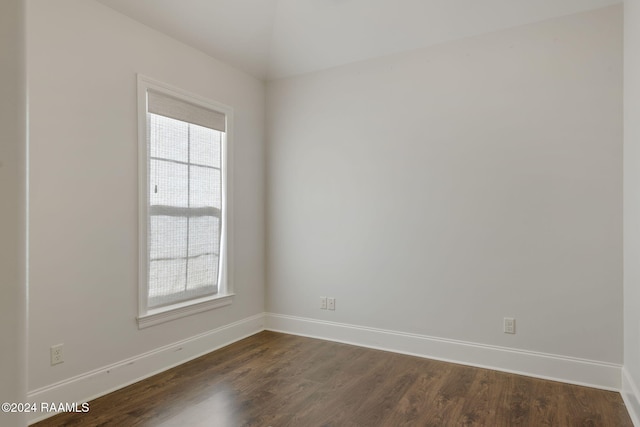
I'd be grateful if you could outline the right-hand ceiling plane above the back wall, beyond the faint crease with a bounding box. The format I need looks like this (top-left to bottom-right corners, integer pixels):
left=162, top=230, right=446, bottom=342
left=268, top=0, right=620, bottom=78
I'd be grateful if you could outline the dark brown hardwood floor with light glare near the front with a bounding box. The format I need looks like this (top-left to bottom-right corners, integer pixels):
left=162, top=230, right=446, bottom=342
left=35, top=332, right=633, bottom=427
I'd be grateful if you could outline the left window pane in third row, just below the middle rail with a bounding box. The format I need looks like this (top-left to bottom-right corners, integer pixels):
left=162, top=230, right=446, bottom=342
left=149, top=215, right=187, bottom=260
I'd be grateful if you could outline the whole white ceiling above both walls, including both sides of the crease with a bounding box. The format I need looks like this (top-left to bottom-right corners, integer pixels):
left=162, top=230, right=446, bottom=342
left=98, top=0, right=621, bottom=79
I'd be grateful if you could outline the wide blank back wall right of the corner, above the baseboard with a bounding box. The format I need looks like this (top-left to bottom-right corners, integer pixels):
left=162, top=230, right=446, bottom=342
left=267, top=5, right=623, bottom=364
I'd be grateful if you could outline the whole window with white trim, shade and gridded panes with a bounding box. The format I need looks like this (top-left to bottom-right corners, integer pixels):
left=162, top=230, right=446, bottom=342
left=138, top=76, right=233, bottom=328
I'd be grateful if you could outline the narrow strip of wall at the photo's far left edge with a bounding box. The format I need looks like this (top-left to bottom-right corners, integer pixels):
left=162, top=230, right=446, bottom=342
left=0, top=0, right=27, bottom=427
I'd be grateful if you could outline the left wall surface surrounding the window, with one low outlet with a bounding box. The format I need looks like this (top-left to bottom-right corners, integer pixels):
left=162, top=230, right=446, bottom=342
left=28, top=0, right=264, bottom=391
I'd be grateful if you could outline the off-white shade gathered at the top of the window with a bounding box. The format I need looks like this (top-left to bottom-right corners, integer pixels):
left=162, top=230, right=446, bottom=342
left=147, top=90, right=226, bottom=132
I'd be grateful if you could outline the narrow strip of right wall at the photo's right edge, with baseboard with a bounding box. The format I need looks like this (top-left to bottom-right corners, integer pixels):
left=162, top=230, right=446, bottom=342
left=623, top=0, right=640, bottom=425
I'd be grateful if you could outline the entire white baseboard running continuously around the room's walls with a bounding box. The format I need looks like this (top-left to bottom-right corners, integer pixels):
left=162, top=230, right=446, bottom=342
left=27, top=313, right=628, bottom=427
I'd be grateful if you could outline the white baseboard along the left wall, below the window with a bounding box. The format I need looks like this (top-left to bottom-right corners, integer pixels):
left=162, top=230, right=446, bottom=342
left=27, top=313, right=264, bottom=424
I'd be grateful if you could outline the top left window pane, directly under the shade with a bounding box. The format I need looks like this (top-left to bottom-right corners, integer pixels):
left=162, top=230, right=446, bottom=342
left=149, top=113, right=189, bottom=162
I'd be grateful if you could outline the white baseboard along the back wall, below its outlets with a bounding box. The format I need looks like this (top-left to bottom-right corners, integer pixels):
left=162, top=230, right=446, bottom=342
left=265, top=313, right=622, bottom=391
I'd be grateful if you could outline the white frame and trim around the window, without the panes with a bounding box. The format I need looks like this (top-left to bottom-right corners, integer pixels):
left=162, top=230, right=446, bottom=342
left=137, top=74, right=234, bottom=329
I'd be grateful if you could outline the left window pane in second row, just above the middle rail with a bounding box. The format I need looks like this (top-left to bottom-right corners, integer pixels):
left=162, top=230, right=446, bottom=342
left=149, top=159, right=189, bottom=208
